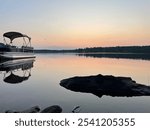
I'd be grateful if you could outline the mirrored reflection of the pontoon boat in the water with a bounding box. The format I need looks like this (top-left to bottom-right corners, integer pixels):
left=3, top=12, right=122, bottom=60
left=0, top=59, right=35, bottom=84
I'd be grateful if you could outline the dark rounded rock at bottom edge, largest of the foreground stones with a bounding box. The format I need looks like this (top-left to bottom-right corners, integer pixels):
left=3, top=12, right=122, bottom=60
left=41, top=105, right=62, bottom=113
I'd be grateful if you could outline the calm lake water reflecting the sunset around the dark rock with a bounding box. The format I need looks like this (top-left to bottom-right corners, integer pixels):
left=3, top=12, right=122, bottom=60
left=0, top=54, right=150, bottom=113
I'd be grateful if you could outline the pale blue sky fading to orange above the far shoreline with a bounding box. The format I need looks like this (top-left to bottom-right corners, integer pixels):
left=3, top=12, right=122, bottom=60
left=0, top=0, right=150, bottom=49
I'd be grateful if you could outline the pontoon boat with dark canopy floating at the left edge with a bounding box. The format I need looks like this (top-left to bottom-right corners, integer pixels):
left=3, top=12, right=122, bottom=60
left=0, top=32, right=35, bottom=59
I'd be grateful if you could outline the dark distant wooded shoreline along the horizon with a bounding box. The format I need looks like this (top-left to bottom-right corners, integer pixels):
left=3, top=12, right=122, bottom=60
left=35, top=46, right=150, bottom=53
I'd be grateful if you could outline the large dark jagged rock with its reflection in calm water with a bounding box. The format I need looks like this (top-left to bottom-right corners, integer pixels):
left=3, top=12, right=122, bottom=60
left=60, top=74, right=150, bottom=97
